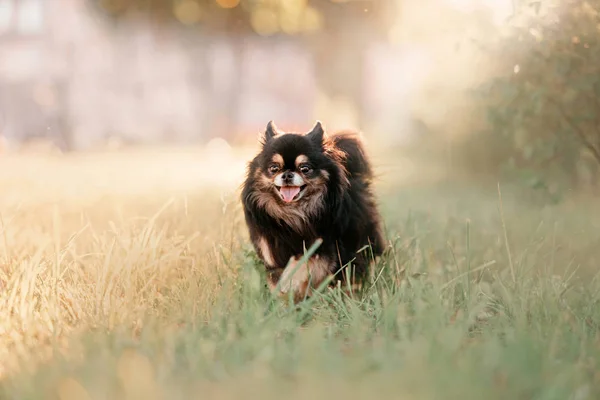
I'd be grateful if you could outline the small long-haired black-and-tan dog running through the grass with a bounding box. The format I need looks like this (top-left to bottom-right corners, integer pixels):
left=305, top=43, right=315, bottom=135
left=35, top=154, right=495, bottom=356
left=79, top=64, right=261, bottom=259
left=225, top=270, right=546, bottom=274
left=241, top=121, right=385, bottom=303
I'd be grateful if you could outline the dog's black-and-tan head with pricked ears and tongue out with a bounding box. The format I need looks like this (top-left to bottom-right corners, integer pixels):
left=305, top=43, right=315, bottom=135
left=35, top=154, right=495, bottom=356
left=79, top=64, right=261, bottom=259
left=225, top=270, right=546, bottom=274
left=245, top=121, right=341, bottom=227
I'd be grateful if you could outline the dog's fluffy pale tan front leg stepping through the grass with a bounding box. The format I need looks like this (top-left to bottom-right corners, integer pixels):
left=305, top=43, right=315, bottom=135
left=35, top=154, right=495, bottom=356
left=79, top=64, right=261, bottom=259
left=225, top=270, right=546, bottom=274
left=272, top=255, right=331, bottom=302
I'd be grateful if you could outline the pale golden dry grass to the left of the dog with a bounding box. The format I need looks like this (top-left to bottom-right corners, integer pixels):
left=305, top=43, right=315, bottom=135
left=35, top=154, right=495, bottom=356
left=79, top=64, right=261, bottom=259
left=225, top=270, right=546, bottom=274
left=0, top=150, right=244, bottom=373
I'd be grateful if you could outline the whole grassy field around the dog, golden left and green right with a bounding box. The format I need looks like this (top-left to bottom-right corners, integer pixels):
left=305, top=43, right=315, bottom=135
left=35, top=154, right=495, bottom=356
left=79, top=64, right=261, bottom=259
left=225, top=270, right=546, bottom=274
left=0, top=145, right=600, bottom=400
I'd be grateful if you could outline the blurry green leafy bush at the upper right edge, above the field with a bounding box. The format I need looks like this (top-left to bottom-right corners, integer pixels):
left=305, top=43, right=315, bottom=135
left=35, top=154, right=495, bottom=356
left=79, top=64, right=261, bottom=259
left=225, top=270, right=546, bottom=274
left=470, top=0, right=600, bottom=195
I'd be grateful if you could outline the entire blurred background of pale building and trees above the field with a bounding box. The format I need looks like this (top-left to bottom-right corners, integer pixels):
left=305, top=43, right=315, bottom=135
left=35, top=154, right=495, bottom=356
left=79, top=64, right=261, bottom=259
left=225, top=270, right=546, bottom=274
left=0, top=0, right=600, bottom=202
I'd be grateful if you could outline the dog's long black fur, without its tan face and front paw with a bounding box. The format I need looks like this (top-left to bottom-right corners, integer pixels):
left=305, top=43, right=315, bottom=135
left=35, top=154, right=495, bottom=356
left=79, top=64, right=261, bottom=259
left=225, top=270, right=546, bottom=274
left=242, top=122, right=385, bottom=296
